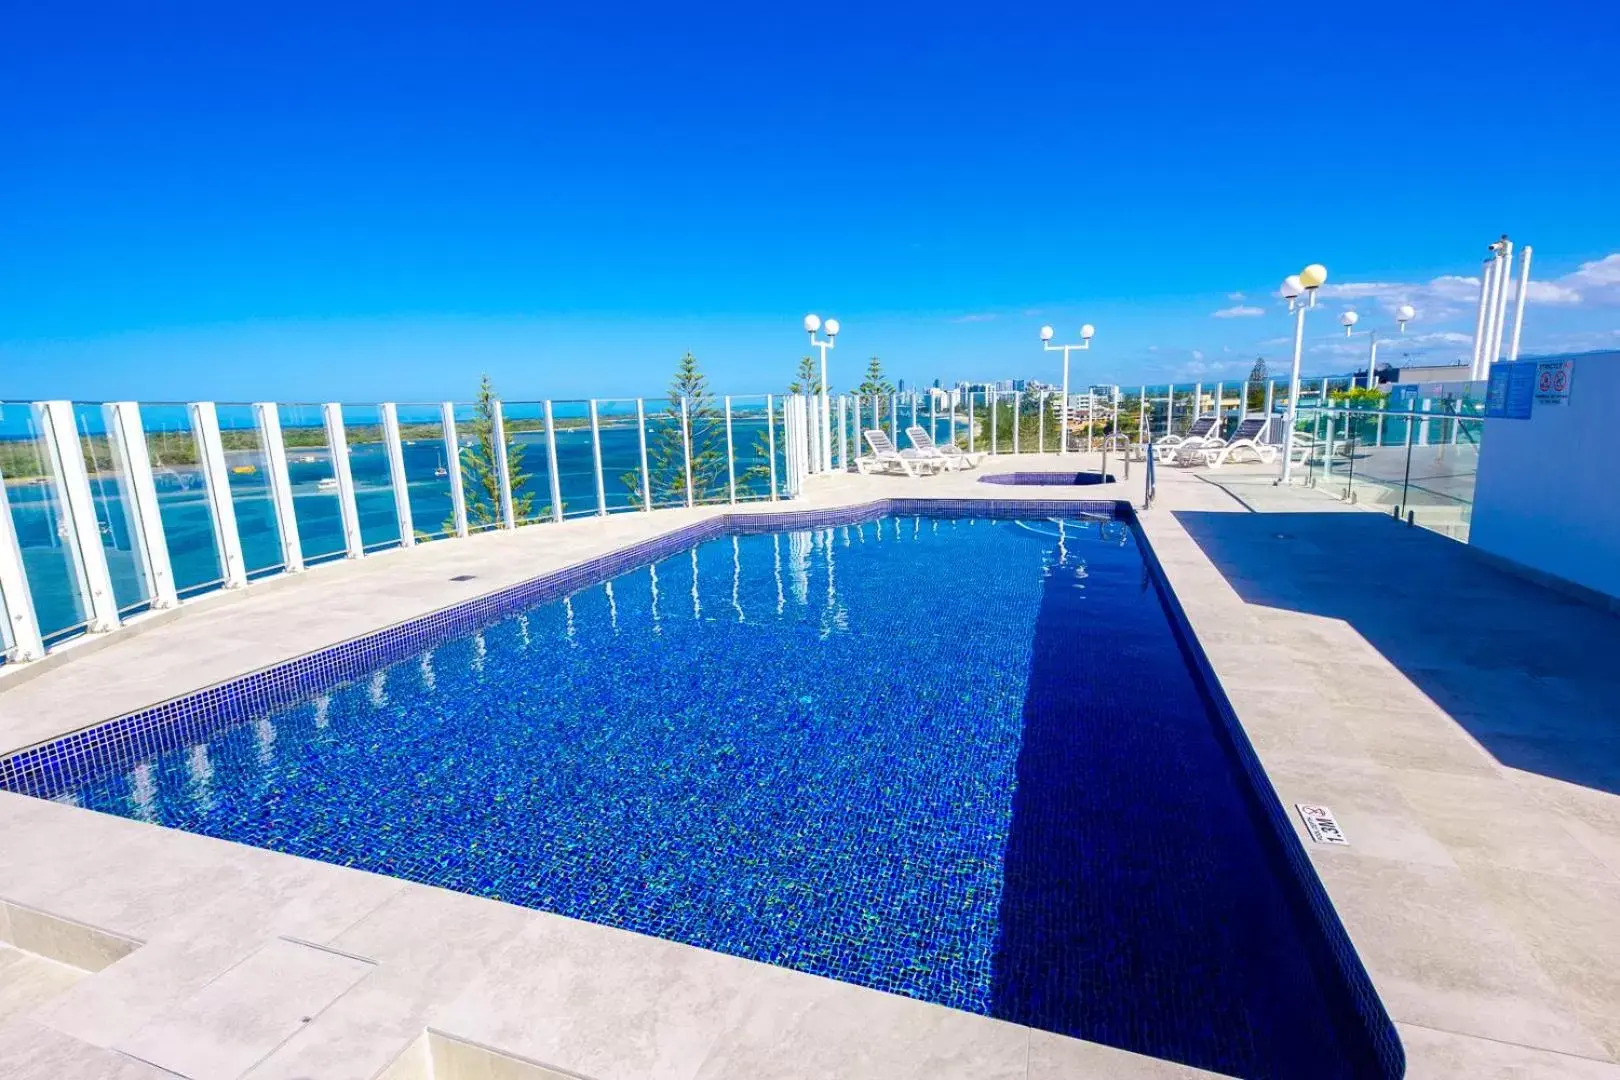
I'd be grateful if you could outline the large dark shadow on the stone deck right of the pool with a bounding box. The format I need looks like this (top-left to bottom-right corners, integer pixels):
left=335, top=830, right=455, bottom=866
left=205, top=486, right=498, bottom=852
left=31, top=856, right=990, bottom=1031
left=1176, top=512, right=1620, bottom=793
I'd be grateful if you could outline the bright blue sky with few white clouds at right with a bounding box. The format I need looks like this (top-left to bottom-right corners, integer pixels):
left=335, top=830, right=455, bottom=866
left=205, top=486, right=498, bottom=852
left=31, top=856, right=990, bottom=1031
left=0, top=0, right=1620, bottom=400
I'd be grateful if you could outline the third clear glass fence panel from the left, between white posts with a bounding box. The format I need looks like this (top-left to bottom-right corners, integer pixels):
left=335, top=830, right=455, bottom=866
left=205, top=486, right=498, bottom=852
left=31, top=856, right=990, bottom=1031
left=141, top=402, right=225, bottom=597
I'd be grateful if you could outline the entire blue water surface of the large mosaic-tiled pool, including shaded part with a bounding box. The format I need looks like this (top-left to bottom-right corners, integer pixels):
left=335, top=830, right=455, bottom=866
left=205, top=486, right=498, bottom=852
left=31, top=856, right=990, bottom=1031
left=50, top=518, right=1375, bottom=1078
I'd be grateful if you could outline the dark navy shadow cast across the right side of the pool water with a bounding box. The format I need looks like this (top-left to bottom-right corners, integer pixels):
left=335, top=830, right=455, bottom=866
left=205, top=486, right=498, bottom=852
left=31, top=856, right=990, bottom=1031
left=991, top=537, right=1383, bottom=1080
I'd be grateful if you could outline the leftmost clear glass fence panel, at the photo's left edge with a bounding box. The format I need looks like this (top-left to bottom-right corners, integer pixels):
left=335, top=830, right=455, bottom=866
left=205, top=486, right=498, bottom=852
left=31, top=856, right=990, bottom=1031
left=0, top=403, right=89, bottom=644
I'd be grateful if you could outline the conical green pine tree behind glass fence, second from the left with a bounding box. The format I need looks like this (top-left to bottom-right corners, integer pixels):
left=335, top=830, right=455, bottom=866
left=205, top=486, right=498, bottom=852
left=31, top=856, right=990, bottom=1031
left=619, top=353, right=726, bottom=502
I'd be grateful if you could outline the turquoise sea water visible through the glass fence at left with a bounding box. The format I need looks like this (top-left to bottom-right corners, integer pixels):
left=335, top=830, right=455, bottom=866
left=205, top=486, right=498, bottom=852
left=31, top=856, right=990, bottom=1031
left=0, top=398, right=948, bottom=643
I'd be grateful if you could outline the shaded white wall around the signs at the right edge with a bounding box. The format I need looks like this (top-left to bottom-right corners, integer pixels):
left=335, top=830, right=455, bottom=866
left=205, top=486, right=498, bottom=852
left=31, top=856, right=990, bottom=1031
left=1468, top=353, right=1620, bottom=597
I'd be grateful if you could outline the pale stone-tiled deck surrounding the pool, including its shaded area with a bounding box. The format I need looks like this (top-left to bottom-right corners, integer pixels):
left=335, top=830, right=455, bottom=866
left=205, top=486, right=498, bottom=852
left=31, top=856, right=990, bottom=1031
left=0, top=455, right=1620, bottom=1080
